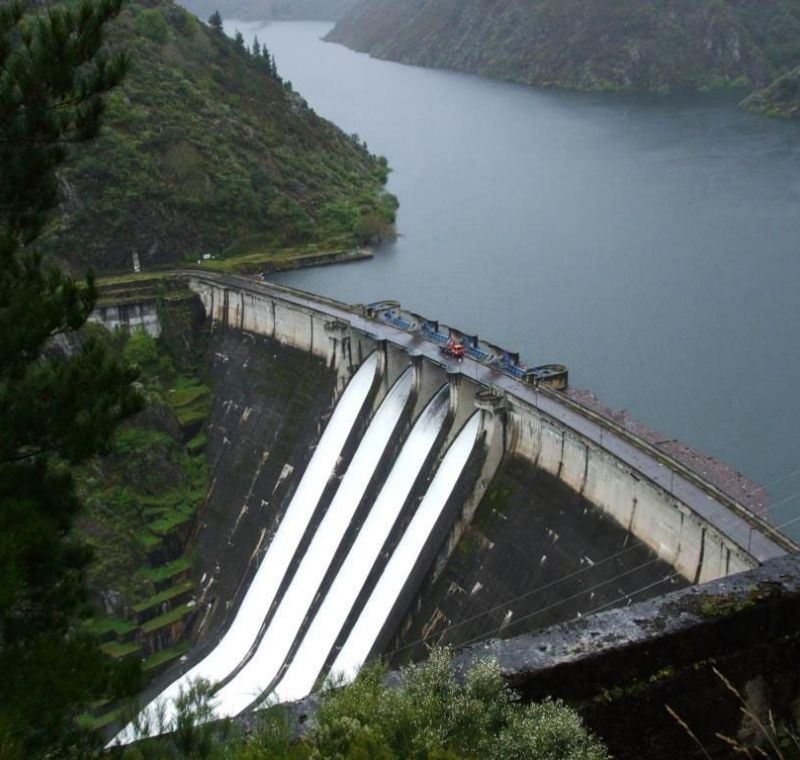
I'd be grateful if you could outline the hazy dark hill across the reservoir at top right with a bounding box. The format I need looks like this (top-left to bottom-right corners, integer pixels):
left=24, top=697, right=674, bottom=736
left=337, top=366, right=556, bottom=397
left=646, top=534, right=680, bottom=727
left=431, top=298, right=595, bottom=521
left=328, top=0, right=800, bottom=96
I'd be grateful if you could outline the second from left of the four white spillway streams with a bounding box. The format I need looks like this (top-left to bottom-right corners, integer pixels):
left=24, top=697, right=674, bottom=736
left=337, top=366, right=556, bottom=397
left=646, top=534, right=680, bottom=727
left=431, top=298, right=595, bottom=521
left=211, top=368, right=413, bottom=718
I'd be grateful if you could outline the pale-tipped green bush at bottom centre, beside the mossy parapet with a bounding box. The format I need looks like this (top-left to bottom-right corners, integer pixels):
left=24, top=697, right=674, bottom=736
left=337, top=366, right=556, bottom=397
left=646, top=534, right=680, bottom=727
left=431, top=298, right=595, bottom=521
left=239, top=650, right=609, bottom=760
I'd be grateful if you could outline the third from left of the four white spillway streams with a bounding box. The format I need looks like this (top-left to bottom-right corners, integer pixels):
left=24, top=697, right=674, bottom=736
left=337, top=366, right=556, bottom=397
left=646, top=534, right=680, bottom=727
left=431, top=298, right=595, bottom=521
left=269, top=386, right=448, bottom=703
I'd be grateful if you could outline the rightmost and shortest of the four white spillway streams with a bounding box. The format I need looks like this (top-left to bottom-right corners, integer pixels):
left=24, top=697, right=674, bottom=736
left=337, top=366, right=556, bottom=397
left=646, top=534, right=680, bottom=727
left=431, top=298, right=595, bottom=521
left=331, top=413, right=480, bottom=680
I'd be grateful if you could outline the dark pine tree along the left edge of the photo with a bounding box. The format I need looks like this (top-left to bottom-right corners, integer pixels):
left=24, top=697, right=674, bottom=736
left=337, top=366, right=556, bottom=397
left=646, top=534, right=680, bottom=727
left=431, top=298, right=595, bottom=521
left=0, top=0, right=140, bottom=757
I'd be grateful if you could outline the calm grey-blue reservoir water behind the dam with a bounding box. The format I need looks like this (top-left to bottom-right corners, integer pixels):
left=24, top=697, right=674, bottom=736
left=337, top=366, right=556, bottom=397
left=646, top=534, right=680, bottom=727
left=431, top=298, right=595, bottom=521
left=226, top=21, right=800, bottom=536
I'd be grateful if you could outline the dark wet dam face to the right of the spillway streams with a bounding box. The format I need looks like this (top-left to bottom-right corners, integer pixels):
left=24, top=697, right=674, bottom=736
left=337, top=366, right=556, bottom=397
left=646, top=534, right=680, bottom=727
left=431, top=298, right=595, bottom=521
left=387, top=458, right=688, bottom=664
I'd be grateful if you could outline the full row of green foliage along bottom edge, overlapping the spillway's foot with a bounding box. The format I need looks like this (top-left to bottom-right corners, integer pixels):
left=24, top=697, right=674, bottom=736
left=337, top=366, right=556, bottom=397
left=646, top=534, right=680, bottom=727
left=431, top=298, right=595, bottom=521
left=115, top=649, right=610, bottom=760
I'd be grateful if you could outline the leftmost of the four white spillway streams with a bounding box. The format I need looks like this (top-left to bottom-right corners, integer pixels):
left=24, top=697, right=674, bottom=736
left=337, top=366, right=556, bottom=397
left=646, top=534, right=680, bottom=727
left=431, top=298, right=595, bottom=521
left=111, top=353, right=378, bottom=745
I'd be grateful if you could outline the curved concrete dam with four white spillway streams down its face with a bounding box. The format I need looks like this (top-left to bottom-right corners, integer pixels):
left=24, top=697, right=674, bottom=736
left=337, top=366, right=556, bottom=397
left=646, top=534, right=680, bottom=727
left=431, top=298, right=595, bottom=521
left=104, top=272, right=795, bottom=743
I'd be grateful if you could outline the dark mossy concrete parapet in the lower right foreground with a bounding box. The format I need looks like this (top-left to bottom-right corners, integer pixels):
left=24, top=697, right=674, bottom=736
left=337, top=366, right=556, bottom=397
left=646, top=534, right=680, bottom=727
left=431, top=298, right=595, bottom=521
left=454, top=555, right=800, bottom=760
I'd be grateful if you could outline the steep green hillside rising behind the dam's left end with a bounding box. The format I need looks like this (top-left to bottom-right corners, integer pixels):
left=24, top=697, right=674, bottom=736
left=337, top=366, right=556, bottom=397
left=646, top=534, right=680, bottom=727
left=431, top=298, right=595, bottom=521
left=46, top=0, right=396, bottom=271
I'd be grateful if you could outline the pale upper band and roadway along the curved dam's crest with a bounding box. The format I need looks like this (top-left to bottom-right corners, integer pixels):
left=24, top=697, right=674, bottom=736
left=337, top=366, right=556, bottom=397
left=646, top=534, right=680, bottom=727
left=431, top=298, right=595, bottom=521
left=183, top=273, right=793, bottom=583
